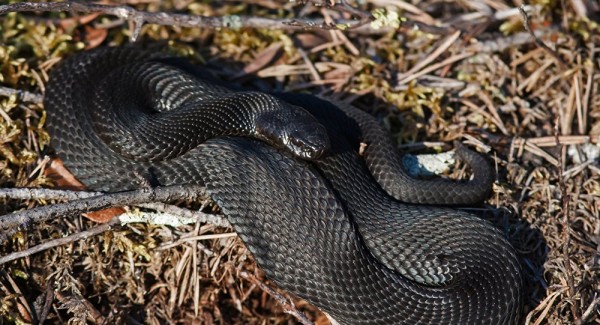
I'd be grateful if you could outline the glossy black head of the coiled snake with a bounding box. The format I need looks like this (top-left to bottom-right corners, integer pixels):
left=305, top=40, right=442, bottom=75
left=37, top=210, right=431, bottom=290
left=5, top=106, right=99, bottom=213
left=256, top=103, right=330, bottom=160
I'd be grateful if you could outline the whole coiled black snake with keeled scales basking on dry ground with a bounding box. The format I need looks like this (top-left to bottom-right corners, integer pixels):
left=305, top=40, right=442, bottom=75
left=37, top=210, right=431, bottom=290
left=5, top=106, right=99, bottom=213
left=44, top=46, right=524, bottom=324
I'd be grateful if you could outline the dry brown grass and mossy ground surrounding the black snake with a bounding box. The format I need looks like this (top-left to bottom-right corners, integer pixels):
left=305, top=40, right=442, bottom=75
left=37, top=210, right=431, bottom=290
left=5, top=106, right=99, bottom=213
left=0, top=0, right=600, bottom=324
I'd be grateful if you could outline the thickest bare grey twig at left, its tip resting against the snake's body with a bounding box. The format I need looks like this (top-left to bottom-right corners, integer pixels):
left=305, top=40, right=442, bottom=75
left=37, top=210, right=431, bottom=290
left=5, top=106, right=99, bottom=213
left=0, top=185, right=205, bottom=241
